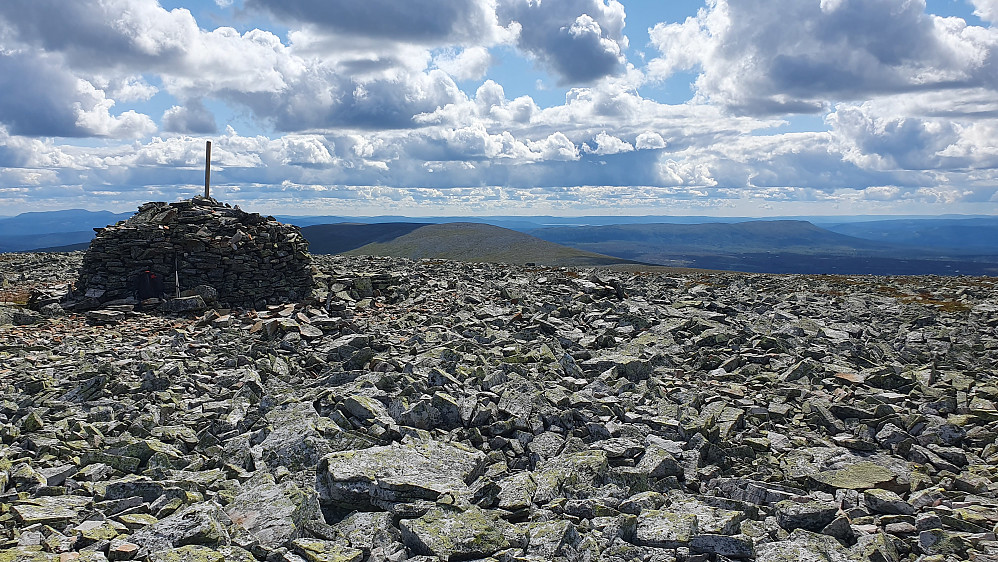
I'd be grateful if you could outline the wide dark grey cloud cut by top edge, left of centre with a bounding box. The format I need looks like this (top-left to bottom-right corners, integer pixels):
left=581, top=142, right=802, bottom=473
left=246, top=0, right=499, bottom=45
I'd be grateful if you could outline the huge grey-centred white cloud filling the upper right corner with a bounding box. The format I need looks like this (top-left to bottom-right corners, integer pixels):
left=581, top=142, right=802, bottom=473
left=648, top=0, right=998, bottom=114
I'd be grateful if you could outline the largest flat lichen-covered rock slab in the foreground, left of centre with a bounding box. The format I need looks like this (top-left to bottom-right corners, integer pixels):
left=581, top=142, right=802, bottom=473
left=316, top=441, right=485, bottom=510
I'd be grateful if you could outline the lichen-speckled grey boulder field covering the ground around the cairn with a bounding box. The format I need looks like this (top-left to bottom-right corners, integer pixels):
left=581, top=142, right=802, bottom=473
left=0, top=254, right=998, bottom=562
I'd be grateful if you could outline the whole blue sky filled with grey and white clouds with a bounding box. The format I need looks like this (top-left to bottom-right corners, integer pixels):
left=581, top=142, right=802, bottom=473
left=0, top=0, right=998, bottom=217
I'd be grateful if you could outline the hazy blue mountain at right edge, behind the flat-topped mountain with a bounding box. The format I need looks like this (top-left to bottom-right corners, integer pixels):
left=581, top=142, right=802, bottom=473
left=825, top=217, right=998, bottom=250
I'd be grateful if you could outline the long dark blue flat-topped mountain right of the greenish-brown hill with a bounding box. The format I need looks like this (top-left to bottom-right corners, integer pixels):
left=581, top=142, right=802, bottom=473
left=530, top=221, right=998, bottom=275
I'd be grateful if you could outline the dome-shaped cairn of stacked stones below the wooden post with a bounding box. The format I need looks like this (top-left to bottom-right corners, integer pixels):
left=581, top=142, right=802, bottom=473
left=66, top=196, right=313, bottom=312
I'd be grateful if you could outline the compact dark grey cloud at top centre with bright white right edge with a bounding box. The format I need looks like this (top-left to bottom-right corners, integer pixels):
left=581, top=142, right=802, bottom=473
left=497, top=0, right=627, bottom=84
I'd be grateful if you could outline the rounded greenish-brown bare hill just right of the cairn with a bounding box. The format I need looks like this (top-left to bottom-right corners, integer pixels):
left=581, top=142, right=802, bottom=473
left=328, top=223, right=634, bottom=266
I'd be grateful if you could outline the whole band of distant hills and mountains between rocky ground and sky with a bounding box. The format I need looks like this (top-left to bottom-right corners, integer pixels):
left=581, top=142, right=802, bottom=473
left=0, top=209, right=998, bottom=275
